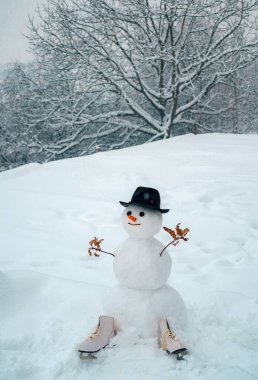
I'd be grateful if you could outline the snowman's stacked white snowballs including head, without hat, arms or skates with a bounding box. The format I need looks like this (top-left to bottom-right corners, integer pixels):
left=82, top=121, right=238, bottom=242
left=106, top=205, right=186, bottom=337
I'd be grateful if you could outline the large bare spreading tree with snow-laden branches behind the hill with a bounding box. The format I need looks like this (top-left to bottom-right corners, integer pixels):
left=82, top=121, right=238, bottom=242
left=26, top=0, right=258, bottom=153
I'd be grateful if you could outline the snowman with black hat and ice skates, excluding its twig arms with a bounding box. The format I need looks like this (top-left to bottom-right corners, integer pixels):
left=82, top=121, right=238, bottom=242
left=78, top=186, right=187, bottom=359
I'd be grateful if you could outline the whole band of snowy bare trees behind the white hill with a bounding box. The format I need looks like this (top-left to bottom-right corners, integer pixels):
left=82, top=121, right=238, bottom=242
left=0, top=0, right=258, bottom=170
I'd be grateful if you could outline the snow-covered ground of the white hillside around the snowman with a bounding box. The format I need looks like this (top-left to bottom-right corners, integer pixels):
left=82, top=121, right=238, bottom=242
left=0, top=134, right=258, bottom=380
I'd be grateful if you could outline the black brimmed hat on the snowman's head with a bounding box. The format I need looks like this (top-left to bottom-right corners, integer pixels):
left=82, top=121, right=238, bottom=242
left=120, top=186, right=169, bottom=214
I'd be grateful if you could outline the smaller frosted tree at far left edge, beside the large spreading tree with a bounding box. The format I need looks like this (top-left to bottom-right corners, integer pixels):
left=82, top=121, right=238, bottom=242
left=0, top=63, right=39, bottom=169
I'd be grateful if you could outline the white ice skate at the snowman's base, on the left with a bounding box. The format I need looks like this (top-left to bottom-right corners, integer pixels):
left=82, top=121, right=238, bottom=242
left=78, top=315, right=115, bottom=359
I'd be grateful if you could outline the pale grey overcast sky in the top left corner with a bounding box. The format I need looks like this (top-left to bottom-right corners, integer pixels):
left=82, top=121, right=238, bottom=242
left=0, top=0, right=43, bottom=65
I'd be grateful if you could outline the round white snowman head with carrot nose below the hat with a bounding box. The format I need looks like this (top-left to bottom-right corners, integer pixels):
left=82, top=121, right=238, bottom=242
left=122, top=205, right=162, bottom=239
